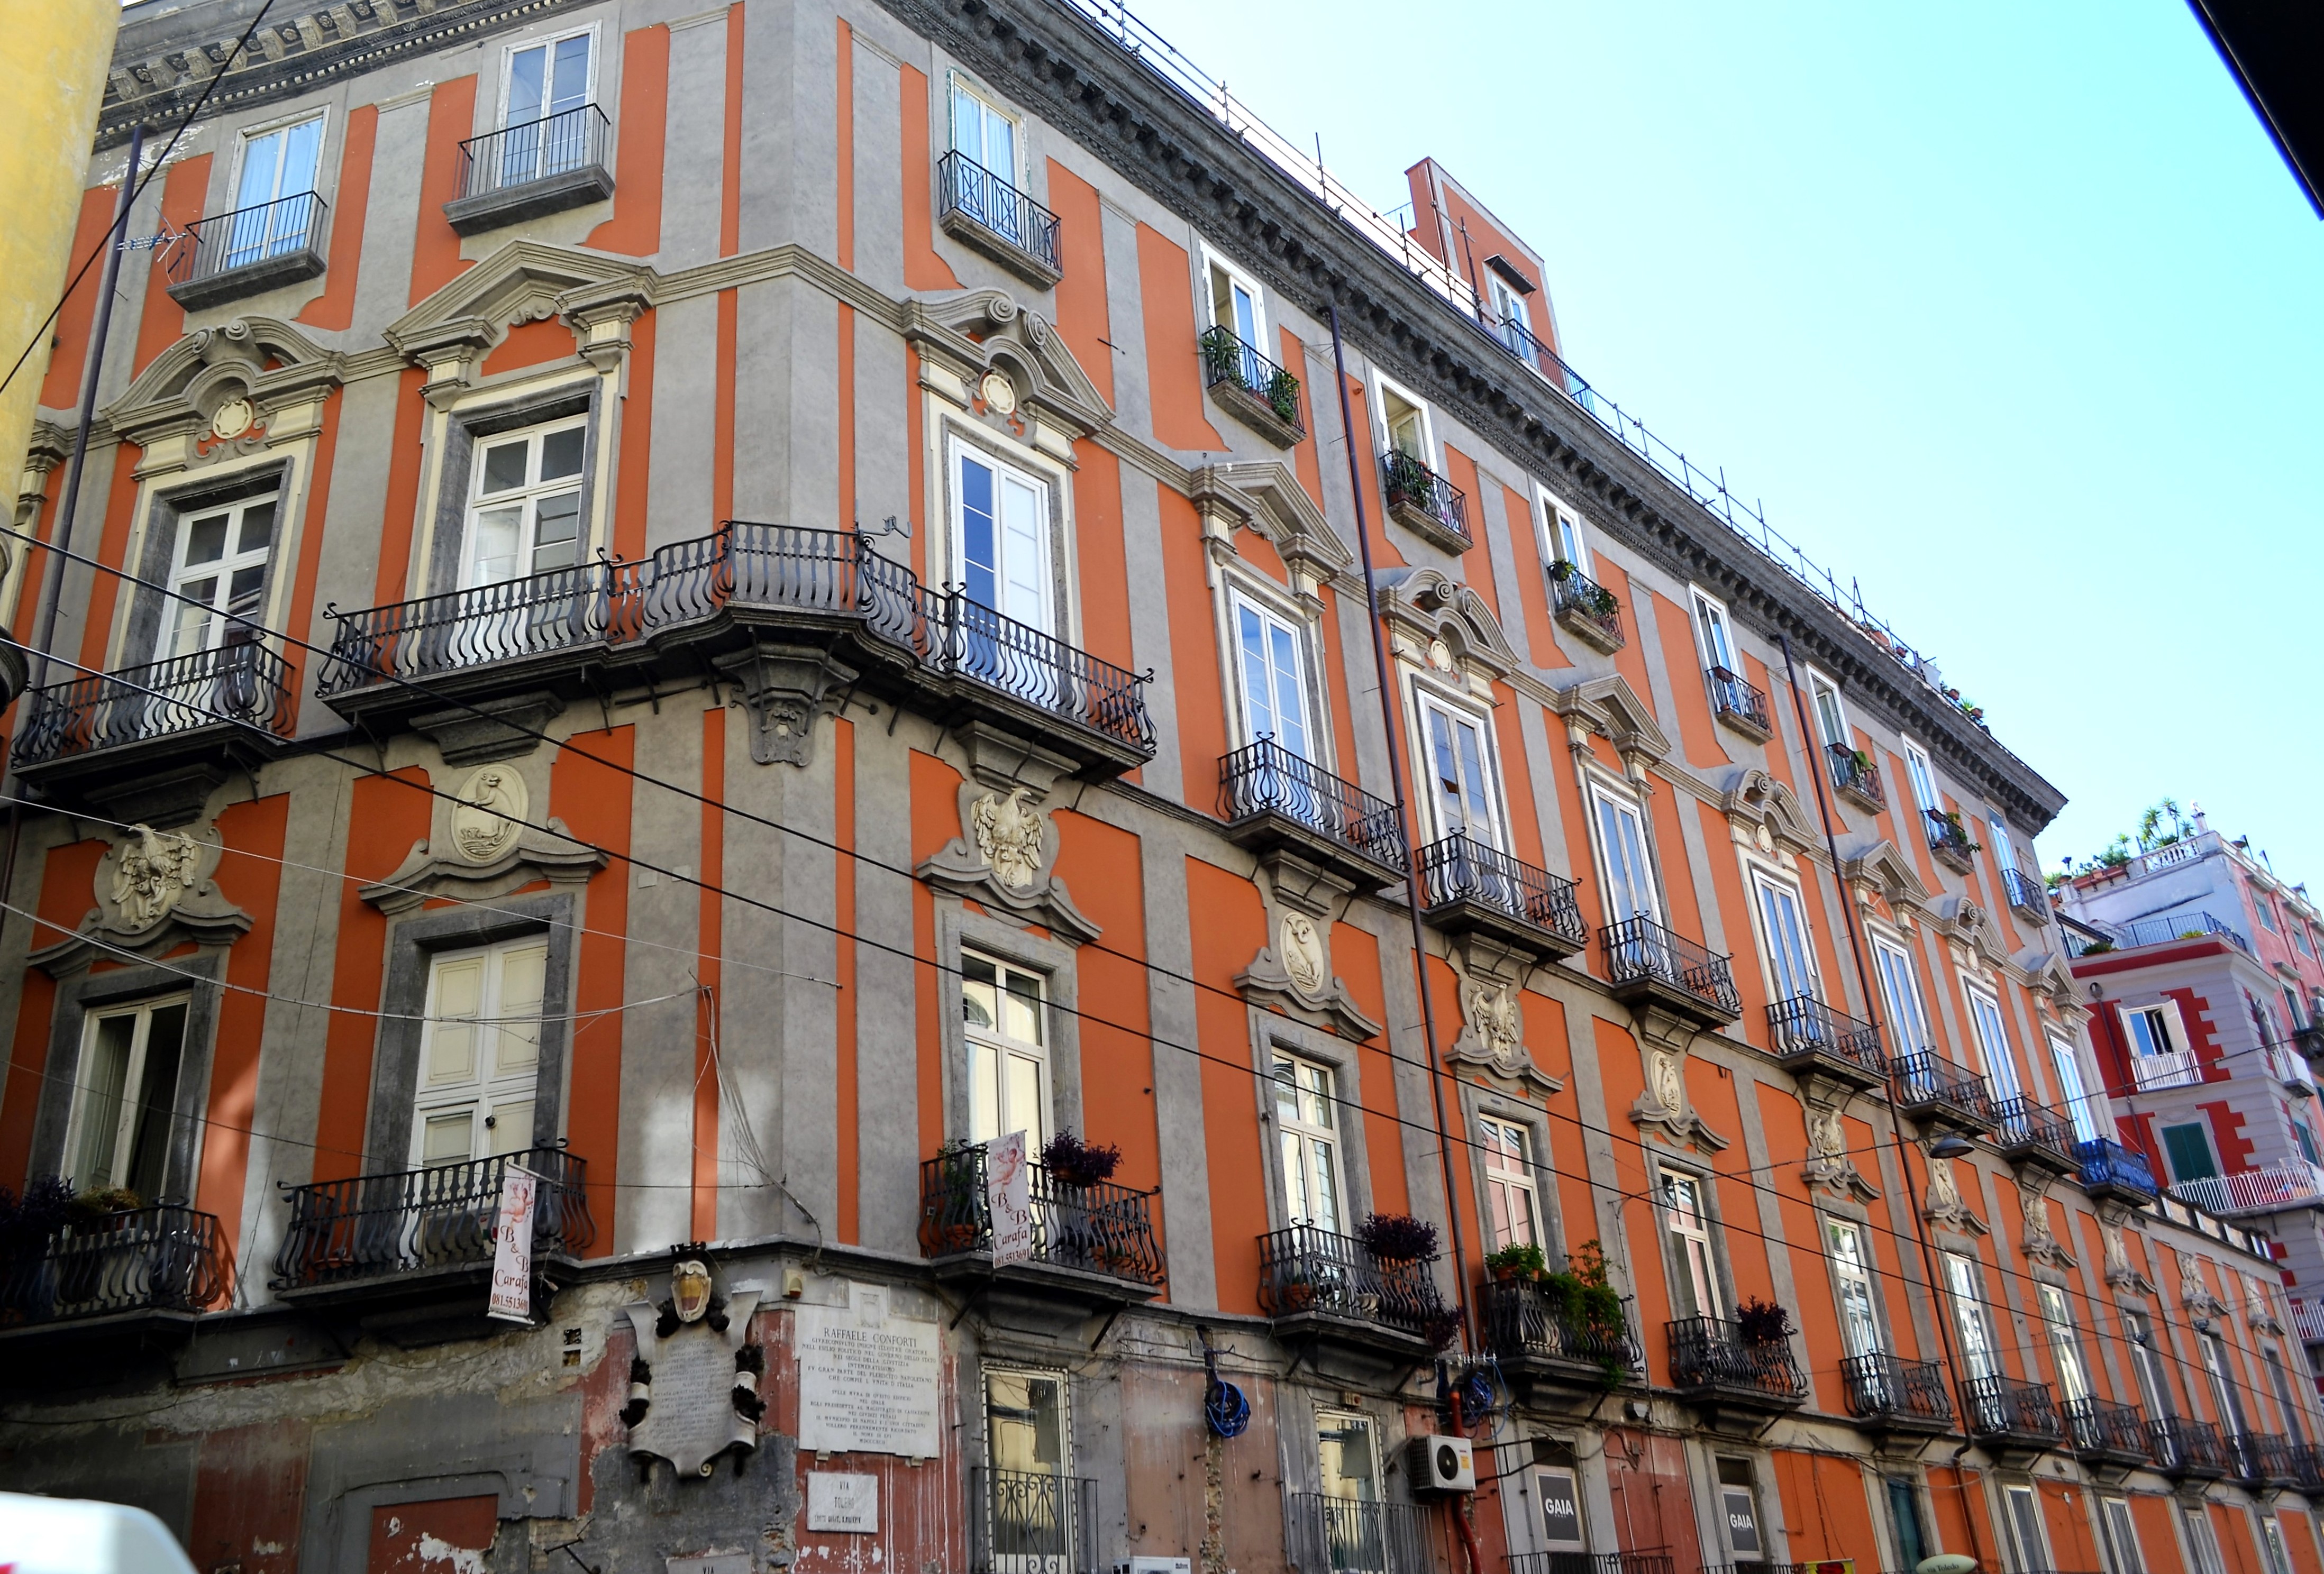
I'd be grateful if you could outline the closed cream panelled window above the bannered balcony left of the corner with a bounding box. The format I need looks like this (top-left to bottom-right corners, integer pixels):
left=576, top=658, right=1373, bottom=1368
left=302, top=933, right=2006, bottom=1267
left=412, top=937, right=549, bottom=1165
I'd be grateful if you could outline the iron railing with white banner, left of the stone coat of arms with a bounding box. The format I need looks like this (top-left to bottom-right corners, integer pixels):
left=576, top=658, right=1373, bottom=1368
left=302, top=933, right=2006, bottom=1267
left=274, top=1149, right=597, bottom=1291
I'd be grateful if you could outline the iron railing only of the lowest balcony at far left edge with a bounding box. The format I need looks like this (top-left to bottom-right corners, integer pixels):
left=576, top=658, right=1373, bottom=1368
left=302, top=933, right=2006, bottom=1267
left=0, top=1202, right=235, bottom=1323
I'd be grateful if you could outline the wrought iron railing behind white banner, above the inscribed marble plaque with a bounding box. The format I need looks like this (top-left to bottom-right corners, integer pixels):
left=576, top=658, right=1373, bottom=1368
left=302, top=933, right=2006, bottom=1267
left=921, top=1144, right=1166, bottom=1286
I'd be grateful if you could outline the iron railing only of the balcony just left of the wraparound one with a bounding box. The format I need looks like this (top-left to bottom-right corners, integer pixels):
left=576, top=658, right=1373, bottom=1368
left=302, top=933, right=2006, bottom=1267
left=14, top=642, right=295, bottom=770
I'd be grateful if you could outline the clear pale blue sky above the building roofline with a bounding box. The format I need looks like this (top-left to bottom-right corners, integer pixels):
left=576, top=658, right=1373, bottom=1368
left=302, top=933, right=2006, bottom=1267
left=1136, top=0, right=2324, bottom=891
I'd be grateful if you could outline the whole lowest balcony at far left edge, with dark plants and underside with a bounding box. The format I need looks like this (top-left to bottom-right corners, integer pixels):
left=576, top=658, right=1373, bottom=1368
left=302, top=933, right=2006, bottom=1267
left=0, top=1202, right=235, bottom=1348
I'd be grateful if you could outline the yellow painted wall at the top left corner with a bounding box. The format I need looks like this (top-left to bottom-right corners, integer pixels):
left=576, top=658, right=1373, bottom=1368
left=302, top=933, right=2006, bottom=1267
left=0, top=0, right=121, bottom=486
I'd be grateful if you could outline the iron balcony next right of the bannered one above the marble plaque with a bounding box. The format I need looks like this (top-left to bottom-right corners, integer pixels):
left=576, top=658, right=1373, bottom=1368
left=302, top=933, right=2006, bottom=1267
left=1260, top=1225, right=1455, bottom=1360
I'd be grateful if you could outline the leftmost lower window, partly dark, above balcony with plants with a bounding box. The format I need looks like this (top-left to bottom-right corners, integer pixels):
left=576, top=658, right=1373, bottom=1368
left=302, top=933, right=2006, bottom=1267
left=65, top=998, right=190, bottom=1202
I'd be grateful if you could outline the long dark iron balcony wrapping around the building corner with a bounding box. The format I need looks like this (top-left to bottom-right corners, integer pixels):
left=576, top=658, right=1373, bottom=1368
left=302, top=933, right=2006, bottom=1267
left=316, top=521, right=1155, bottom=772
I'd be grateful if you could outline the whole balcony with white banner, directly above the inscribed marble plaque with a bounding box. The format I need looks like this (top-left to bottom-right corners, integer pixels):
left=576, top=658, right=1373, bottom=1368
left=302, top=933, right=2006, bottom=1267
left=921, top=1144, right=1166, bottom=1318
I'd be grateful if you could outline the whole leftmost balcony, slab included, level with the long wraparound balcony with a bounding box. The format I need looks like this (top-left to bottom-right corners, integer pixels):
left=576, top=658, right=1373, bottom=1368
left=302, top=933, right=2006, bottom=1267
left=12, top=642, right=297, bottom=826
